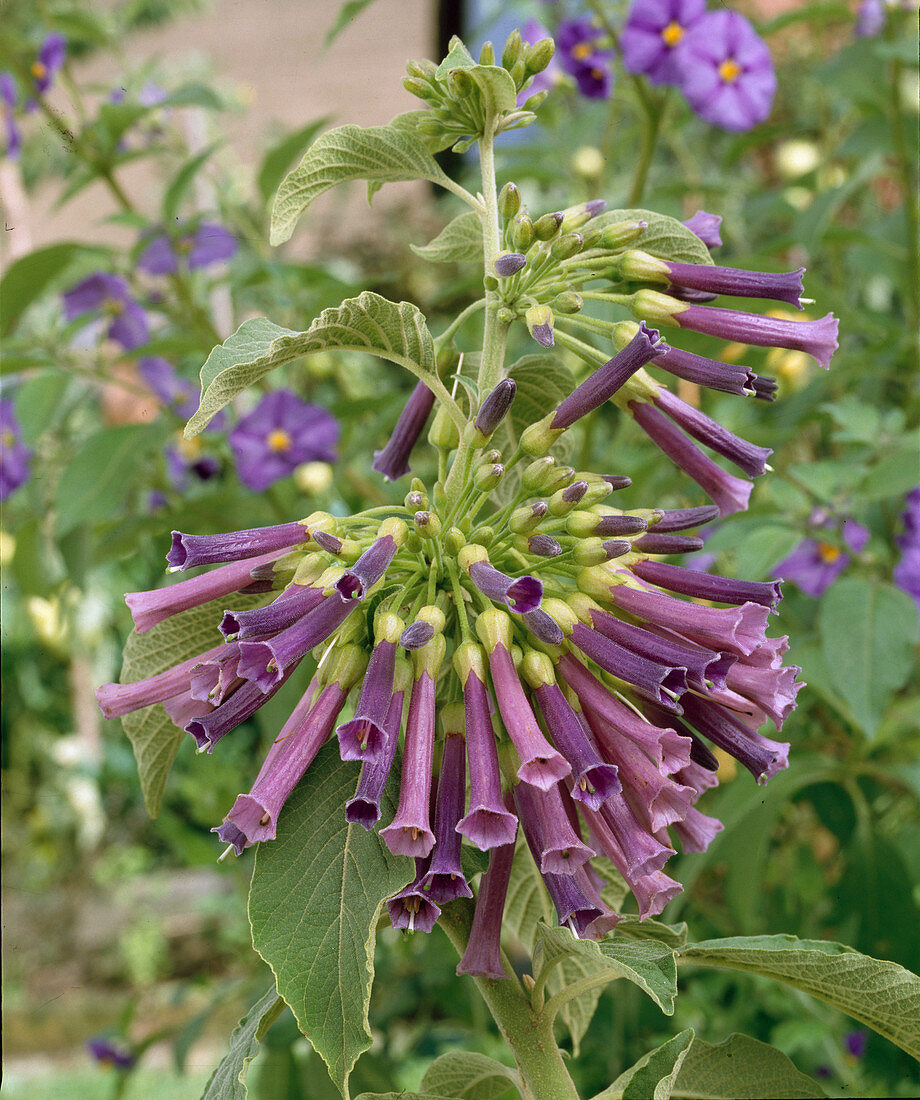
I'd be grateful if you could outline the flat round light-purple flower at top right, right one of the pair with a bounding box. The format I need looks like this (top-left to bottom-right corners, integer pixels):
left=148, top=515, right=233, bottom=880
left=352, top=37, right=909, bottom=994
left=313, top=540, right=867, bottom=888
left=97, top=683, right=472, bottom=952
left=677, top=10, right=776, bottom=131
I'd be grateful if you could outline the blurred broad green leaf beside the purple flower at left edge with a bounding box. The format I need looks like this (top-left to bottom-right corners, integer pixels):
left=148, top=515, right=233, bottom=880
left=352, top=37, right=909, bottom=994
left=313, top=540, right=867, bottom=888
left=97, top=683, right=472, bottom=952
left=55, top=425, right=163, bottom=536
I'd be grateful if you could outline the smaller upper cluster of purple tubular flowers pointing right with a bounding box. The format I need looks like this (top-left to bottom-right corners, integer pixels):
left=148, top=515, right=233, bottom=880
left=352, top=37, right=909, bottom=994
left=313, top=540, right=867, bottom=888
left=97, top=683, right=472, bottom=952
left=489, top=184, right=837, bottom=516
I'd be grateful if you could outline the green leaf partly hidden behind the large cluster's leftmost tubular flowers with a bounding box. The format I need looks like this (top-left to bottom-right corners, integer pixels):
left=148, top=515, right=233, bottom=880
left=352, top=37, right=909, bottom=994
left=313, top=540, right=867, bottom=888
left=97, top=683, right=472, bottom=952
left=121, top=593, right=272, bottom=817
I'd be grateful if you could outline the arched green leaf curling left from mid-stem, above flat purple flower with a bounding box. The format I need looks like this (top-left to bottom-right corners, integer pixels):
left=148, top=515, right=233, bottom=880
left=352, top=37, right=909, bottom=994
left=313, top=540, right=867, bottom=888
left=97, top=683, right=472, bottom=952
left=185, top=290, right=453, bottom=439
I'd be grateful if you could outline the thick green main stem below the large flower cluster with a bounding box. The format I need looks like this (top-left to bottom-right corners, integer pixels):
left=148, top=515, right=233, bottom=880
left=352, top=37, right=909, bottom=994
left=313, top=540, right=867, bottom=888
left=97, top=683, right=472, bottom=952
left=438, top=900, right=578, bottom=1100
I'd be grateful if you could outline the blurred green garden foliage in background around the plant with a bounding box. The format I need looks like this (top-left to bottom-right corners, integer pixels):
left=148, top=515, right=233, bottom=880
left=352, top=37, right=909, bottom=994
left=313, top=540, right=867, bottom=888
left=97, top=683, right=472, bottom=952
left=0, top=0, right=920, bottom=1100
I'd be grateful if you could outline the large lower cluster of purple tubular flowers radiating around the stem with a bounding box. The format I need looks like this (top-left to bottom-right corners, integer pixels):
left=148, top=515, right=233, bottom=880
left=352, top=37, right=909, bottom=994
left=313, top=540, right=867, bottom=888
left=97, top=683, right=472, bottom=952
left=97, top=308, right=798, bottom=977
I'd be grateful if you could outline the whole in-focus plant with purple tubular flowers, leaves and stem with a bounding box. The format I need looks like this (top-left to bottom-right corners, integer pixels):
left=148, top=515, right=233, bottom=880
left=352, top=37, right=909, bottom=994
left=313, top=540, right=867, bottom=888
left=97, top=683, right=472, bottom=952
left=98, top=32, right=917, bottom=1100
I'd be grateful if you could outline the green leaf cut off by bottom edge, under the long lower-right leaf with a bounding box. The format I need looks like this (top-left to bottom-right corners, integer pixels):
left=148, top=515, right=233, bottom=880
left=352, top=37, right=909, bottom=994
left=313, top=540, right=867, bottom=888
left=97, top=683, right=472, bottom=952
left=671, top=1034, right=826, bottom=1100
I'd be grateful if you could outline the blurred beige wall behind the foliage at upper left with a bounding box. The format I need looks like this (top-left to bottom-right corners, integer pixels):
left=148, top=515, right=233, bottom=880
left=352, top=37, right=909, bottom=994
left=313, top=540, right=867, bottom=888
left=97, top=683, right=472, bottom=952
left=2, top=0, right=437, bottom=260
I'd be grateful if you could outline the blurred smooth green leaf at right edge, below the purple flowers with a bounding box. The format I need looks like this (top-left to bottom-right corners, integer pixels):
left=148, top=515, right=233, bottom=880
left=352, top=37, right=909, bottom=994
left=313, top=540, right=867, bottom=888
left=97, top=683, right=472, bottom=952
left=819, top=576, right=918, bottom=737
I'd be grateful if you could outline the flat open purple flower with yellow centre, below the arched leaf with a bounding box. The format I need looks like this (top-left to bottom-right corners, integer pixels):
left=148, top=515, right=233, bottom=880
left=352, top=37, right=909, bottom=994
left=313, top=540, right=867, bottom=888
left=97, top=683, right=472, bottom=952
left=230, top=389, right=339, bottom=493
